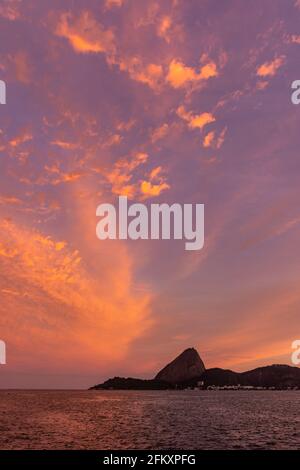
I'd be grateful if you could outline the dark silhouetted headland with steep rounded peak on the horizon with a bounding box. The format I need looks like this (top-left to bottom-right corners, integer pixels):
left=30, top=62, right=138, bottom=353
left=90, top=348, right=300, bottom=390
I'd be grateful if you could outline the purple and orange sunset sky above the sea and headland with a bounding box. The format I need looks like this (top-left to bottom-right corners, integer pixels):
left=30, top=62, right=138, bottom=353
left=0, top=0, right=300, bottom=388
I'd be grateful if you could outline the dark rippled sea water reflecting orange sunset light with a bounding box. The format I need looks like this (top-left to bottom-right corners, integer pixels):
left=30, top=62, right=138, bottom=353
left=0, top=391, right=300, bottom=450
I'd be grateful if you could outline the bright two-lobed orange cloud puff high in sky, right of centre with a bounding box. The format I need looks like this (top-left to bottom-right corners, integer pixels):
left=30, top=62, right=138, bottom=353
left=166, top=59, right=218, bottom=88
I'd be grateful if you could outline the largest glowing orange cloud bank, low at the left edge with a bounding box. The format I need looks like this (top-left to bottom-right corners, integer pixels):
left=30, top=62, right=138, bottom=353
left=0, top=221, right=149, bottom=373
